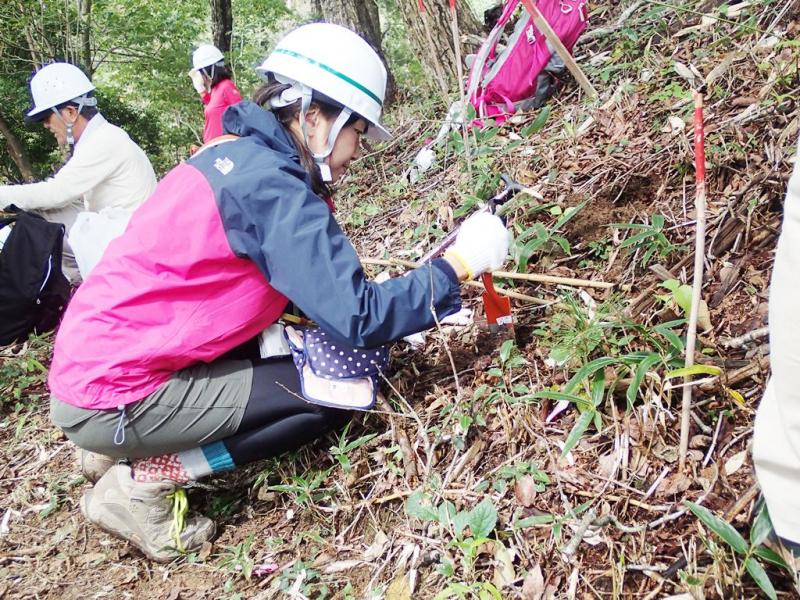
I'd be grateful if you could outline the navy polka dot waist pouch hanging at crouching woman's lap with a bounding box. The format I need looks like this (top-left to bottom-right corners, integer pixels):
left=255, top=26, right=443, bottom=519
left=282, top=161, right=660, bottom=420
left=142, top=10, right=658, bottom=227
left=284, top=326, right=389, bottom=410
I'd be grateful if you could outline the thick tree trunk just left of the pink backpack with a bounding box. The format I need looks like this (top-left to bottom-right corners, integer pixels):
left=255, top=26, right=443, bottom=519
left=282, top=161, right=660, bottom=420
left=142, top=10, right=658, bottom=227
left=397, top=0, right=480, bottom=95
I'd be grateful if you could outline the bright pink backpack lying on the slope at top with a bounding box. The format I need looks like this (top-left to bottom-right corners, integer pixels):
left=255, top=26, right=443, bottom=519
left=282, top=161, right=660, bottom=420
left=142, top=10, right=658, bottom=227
left=467, top=0, right=587, bottom=124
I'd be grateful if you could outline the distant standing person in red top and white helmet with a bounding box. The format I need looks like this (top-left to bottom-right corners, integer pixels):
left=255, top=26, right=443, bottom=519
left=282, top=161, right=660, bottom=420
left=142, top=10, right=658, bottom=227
left=189, top=44, right=242, bottom=143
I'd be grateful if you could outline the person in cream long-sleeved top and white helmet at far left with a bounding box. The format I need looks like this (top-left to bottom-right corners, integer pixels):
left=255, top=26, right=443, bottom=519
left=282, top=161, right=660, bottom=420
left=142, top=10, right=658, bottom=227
left=0, top=63, right=156, bottom=281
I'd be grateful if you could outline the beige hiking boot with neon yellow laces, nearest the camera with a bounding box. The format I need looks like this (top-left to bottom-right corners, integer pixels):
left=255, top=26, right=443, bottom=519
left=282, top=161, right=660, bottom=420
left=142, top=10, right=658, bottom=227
left=81, top=464, right=215, bottom=562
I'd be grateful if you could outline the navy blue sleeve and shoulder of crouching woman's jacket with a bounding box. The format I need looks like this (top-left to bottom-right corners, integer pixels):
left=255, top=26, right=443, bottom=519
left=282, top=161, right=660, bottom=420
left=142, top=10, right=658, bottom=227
left=204, top=140, right=461, bottom=347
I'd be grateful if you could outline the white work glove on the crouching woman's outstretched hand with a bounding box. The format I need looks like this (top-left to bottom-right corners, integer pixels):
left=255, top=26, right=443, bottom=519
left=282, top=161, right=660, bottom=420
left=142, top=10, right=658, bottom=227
left=444, top=211, right=509, bottom=279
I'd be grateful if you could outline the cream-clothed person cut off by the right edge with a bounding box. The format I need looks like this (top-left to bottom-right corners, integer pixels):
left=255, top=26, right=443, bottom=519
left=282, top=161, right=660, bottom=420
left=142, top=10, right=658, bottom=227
left=753, top=139, right=800, bottom=569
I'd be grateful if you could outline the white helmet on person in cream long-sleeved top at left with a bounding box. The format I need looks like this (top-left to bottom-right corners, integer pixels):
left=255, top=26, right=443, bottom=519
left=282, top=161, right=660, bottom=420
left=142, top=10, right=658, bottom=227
left=27, top=63, right=97, bottom=119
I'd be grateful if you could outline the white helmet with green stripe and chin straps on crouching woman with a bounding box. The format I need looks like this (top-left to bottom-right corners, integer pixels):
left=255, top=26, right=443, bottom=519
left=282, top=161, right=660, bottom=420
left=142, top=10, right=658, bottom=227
left=256, top=23, right=392, bottom=180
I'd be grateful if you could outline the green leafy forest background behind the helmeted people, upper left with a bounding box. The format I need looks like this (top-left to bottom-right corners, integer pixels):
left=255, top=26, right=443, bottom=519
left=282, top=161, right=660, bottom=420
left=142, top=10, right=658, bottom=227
left=0, top=0, right=290, bottom=182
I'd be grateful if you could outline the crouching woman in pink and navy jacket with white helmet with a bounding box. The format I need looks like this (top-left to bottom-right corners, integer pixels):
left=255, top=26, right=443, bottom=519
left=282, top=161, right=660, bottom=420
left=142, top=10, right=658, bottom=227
left=49, top=23, right=509, bottom=561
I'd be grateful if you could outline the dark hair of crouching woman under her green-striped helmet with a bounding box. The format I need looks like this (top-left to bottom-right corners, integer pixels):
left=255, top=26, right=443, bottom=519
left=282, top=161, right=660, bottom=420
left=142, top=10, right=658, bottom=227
left=253, top=79, right=361, bottom=198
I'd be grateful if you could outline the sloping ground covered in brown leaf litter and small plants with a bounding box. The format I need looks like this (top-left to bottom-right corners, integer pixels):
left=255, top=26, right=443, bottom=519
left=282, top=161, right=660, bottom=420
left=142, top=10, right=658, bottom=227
left=0, top=1, right=800, bottom=600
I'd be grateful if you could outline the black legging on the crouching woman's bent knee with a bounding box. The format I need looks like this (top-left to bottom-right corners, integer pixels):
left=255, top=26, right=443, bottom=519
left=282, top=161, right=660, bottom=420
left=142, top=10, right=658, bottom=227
left=223, top=359, right=352, bottom=466
